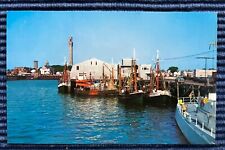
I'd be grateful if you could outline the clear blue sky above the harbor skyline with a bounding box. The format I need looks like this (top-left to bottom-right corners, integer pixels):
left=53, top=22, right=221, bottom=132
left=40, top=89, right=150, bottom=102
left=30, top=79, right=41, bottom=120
left=7, top=11, right=217, bottom=69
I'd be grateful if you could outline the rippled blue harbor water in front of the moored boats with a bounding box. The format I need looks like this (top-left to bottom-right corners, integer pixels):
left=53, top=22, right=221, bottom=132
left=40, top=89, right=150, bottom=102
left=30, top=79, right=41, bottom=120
left=7, top=80, right=187, bottom=144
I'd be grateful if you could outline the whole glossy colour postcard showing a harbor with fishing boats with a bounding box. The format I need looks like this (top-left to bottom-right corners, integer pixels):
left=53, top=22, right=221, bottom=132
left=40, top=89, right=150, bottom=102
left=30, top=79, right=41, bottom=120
left=6, top=11, right=217, bottom=144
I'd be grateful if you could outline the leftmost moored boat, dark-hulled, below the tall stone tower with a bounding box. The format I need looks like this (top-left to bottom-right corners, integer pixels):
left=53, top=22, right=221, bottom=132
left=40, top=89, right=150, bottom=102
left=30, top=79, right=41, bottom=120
left=58, top=63, right=71, bottom=93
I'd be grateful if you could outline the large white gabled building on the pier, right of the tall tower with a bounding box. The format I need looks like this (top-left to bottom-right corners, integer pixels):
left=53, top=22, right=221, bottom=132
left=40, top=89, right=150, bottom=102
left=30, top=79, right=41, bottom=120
left=70, top=58, right=117, bottom=80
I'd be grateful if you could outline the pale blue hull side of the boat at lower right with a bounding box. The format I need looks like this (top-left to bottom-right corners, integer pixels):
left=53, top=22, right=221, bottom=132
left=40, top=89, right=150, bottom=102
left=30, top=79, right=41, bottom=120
left=175, top=108, right=215, bottom=144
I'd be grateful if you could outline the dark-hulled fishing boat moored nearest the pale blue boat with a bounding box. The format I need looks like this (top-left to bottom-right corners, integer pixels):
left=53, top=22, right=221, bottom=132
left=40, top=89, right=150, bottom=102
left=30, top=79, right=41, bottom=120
left=144, top=50, right=173, bottom=106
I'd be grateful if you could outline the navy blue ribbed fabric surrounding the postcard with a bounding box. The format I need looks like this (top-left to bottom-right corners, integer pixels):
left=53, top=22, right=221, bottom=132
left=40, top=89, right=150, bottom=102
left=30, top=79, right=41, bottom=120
left=0, top=0, right=225, bottom=150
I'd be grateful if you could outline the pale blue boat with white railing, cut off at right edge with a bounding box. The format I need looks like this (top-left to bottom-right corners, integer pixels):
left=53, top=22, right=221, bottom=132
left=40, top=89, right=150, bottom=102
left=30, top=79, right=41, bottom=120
left=175, top=93, right=216, bottom=144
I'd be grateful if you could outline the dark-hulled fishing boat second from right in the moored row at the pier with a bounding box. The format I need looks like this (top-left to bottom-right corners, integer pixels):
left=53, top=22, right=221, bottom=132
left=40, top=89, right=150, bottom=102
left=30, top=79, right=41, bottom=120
left=118, top=59, right=144, bottom=104
